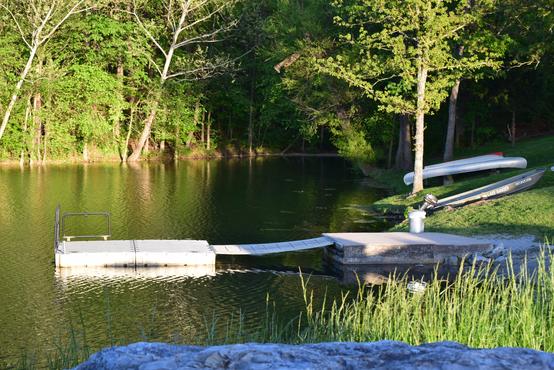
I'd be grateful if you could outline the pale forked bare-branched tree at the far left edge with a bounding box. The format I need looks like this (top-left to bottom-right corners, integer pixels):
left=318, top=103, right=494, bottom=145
left=0, top=0, right=90, bottom=140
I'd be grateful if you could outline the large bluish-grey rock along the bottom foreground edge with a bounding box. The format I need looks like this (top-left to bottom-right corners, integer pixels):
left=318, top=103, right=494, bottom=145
left=76, top=341, right=554, bottom=370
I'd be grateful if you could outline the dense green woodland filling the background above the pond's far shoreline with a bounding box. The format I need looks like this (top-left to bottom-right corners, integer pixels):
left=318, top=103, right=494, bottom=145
left=0, top=0, right=554, bottom=191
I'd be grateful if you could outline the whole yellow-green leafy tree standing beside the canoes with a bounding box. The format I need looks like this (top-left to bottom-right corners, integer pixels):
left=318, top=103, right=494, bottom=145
left=319, top=0, right=498, bottom=194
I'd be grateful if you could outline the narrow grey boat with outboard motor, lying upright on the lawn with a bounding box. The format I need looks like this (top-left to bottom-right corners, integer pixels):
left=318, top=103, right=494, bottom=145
left=420, top=168, right=546, bottom=210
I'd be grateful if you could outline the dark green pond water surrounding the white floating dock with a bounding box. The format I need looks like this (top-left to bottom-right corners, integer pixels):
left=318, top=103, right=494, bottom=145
left=0, top=158, right=385, bottom=364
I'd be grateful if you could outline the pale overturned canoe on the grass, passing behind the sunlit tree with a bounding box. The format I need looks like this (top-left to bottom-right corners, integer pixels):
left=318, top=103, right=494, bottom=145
left=404, top=154, right=527, bottom=185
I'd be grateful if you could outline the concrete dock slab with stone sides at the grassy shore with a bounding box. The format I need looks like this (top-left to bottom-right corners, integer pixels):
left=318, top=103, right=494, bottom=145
left=323, top=232, right=493, bottom=265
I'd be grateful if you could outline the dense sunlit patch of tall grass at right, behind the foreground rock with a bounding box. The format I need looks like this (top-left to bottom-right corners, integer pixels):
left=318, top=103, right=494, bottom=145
left=298, top=250, right=554, bottom=351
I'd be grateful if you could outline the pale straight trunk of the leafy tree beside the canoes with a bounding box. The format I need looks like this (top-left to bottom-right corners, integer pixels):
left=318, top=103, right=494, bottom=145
left=412, top=61, right=427, bottom=194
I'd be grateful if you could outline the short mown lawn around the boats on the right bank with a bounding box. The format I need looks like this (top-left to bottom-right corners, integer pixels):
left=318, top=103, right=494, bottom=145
left=374, top=136, right=554, bottom=238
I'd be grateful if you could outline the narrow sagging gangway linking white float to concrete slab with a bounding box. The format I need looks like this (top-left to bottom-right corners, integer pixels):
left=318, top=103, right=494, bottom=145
left=211, top=236, right=334, bottom=256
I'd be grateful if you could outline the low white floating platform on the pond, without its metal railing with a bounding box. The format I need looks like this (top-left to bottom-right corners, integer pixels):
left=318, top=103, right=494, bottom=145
left=56, top=240, right=215, bottom=267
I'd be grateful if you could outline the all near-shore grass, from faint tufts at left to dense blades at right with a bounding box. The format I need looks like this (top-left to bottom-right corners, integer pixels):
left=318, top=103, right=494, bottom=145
left=10, top=249, right=554, bottom=369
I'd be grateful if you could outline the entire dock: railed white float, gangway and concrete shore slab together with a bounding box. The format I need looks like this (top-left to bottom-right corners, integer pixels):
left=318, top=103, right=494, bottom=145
left=55, top=208, right=493, bottom=268
